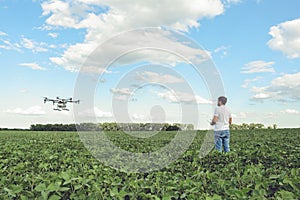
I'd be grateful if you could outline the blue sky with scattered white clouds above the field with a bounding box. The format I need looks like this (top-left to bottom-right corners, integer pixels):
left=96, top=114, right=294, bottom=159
left=0, top=0, right=300, bottom=129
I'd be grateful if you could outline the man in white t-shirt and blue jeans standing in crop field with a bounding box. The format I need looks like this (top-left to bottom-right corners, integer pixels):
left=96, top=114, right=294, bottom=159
left=210, top=96, right=232, bottom=152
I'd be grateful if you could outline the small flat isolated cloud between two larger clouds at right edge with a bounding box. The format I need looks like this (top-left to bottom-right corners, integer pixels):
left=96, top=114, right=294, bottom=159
left=241, top=60, right=275, bottom=74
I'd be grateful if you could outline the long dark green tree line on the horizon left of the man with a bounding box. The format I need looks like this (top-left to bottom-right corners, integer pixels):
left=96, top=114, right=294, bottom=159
left=30, top=122, right=194, bottom=131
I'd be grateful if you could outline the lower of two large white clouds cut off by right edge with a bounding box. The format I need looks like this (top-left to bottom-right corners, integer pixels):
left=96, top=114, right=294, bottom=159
left=252, top=72, right=300, bottom=101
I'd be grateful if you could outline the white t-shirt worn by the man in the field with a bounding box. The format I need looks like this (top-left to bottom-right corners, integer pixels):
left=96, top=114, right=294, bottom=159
left=214, top=105, right=231, bottom=131
